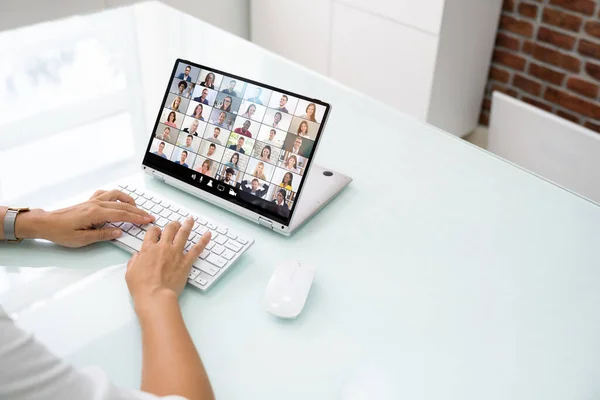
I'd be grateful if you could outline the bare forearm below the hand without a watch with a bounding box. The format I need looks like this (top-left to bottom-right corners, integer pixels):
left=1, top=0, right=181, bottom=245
left=136, top=293, right=214, bottom=400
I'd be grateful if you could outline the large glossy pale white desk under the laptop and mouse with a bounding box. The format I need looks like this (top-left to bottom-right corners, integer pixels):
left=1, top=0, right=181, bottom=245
left=0, top=4, right=600, bottom=400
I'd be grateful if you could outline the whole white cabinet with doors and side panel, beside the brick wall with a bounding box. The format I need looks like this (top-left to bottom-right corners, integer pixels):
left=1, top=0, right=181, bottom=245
left=250, top=0, right=502, bottom=136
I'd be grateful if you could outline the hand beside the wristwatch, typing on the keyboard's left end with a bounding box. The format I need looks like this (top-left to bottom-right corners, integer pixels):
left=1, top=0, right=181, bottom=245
left=15, top=190, right=154, bottom=247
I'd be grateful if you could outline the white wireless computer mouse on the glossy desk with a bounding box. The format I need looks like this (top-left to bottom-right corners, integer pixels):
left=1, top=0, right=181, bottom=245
left=265, top=262, right=315, bottom=318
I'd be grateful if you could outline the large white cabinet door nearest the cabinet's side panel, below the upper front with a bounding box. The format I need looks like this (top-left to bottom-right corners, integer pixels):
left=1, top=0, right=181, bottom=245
left=331, top=4, right=437, bottom=120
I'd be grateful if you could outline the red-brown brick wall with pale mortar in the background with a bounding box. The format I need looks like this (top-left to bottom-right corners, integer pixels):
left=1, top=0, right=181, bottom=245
left=480, top=0, right=600, bottom=133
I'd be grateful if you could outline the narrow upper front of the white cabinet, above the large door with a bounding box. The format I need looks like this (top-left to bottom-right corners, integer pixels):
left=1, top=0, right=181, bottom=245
left=336, top=0, right=446, bottom=35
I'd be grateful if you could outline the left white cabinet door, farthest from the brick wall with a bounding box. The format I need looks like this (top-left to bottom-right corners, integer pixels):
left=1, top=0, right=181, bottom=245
left=250, top=0, right=331, bottom=74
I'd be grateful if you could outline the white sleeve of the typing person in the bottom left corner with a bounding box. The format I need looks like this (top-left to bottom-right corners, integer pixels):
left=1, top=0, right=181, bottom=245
left=0, top=307, right=185, bottom=400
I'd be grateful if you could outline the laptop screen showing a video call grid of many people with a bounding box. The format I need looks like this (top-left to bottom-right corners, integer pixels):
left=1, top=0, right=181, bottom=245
left=144, top=59, right=330, bottom=225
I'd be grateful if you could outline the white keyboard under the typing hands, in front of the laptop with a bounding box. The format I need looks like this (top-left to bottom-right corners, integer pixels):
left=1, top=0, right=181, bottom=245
left=105, top=185, right=254, bottom=290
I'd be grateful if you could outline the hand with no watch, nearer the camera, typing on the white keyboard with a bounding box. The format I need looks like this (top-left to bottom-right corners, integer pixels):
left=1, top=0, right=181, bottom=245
left=125, top=218, right=211, bottom=311
